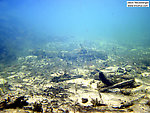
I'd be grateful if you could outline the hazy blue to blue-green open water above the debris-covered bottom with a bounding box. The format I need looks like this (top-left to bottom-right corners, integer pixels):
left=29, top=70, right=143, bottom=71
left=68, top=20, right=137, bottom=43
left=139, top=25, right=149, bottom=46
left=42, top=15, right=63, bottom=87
left=0, top=0, right=150, bottom=51
